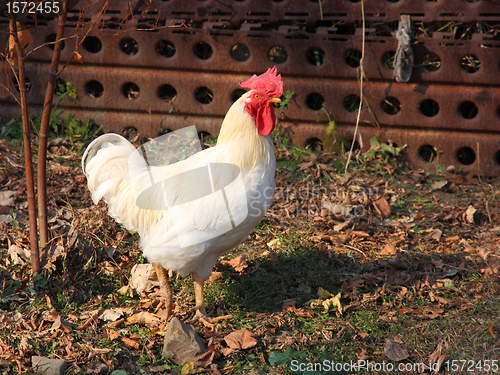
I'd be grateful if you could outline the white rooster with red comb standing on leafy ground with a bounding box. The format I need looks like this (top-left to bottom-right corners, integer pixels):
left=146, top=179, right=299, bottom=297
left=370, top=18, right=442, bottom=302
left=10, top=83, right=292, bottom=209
left=82, top=67, right=283, bottom=318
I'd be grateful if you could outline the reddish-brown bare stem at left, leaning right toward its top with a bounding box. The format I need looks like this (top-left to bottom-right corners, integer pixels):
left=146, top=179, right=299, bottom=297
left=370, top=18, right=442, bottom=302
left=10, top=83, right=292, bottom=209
left=37, top=0, right=68, bottom=248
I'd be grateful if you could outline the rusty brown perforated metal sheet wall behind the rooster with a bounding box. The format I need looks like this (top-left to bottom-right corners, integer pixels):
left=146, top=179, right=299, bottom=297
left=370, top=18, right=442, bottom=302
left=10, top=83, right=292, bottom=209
left=0, top=0, right=500, bottom=175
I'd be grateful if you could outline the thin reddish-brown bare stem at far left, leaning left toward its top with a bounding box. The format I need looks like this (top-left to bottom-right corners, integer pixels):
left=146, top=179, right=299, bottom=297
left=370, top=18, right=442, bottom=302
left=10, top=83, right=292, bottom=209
left=9, top=13, right=40, bottom=275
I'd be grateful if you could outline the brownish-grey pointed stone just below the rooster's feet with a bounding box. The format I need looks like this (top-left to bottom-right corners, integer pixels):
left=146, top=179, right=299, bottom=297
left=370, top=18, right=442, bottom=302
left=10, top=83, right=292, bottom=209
left=162, top=317, right=207, bottom=365
